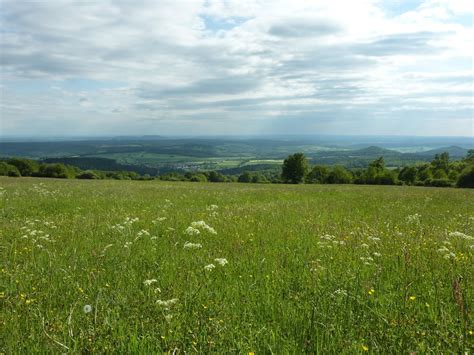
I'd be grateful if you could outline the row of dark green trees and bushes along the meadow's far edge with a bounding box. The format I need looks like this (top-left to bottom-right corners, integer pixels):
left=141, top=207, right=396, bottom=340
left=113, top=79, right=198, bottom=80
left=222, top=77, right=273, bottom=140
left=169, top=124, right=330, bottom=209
left=0, top=149, right=474, bottom=188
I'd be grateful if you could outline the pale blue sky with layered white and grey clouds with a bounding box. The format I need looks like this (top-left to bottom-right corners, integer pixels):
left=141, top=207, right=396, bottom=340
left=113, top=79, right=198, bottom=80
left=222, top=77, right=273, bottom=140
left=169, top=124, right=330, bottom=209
left=0, top=0, right=474, bottom=137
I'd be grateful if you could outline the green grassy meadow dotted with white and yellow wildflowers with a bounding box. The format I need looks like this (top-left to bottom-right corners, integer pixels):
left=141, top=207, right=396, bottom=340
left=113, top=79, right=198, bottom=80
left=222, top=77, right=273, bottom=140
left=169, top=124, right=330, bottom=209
left=0, top=177, right=474, bottom=354
